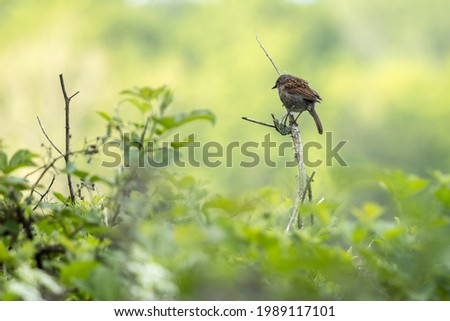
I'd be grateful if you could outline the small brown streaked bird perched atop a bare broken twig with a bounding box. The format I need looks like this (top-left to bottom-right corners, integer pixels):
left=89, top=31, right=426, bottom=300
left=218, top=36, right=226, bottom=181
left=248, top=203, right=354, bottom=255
left=272, top=75, right=323, bottom=134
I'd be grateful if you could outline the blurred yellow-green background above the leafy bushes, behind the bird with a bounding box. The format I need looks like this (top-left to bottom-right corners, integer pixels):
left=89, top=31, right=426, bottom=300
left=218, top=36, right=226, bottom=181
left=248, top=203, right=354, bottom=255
left=0, top=0, right=450, bottom=196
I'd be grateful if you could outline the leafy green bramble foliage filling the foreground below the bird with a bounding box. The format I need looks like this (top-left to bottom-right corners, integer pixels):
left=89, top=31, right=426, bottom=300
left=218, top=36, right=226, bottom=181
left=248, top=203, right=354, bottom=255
left=0, top=87, right=450, bottom=300
